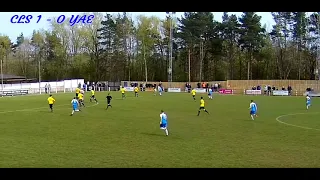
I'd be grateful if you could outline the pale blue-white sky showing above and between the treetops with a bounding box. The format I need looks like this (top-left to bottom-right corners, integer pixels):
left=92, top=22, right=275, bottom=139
left=0, top=12, right=275, bottom=42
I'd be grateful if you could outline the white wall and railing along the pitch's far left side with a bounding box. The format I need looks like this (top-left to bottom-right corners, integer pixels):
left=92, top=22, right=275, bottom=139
left=0, top=79, right=84, bottom=94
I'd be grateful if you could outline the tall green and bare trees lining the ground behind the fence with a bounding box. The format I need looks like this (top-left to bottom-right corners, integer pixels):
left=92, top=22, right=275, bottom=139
left=0, top=12, right=319, bottom=81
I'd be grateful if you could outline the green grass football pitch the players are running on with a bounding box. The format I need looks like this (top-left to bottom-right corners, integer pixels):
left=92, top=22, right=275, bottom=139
left=0, top=92, right=320, bottom=167
